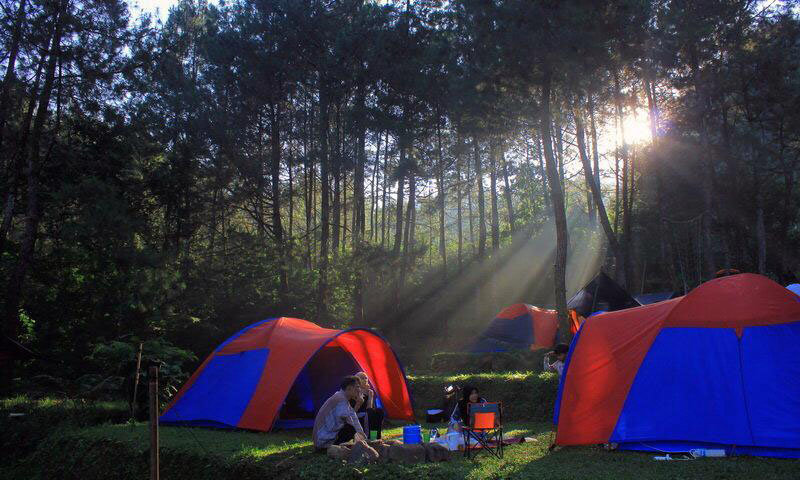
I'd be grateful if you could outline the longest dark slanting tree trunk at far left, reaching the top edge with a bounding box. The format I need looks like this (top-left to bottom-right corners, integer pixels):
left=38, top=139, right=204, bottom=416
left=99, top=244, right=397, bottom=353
left=2, top=0, right=69, bottom=356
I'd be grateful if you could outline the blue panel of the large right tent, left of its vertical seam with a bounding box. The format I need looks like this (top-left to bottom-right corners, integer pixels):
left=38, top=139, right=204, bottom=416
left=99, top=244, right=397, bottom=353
left=610, top=328, right=753, bottom=445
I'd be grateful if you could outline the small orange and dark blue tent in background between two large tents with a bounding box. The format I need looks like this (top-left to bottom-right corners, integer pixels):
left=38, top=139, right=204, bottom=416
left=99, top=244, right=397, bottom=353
left=468, top=303, right=558, bottom=353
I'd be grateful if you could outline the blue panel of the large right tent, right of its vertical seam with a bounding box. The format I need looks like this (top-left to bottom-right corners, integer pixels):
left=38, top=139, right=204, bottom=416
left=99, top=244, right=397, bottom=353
left=742, top=322, right=800, bottom=452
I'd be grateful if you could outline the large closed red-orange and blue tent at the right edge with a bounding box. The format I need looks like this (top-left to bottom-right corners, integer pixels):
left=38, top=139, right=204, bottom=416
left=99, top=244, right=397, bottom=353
left=554, top=274, right=800, bottom=458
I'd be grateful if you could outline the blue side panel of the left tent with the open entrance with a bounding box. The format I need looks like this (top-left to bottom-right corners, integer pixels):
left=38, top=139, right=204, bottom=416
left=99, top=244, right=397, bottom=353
left=161, top=348, right=269, bottom=427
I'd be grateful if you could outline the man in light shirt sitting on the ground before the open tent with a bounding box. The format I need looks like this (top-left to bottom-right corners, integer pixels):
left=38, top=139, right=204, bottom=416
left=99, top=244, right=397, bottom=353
left=311, top=377, right=366, bottom=449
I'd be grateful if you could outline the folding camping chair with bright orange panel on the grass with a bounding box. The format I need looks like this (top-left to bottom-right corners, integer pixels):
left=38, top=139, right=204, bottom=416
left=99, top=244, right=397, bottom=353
left=462, top=402, right=503, bottom=458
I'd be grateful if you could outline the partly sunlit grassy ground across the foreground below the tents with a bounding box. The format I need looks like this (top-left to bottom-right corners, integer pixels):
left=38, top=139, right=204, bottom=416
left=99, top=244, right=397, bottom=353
left=7, top=423, right=800, bottom=480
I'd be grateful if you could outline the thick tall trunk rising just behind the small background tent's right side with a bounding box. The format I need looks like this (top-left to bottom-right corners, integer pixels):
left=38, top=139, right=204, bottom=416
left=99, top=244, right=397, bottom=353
left=539, top=73, right=571, bottom=336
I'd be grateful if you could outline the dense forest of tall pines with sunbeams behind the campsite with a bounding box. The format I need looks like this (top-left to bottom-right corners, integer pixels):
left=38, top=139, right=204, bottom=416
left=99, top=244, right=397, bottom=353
left=0, top=0, right=800, bottom=382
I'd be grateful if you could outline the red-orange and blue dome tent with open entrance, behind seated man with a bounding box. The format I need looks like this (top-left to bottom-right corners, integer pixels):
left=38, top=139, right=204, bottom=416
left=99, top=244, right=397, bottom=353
left=160, top=317, right=414, bottom=431
